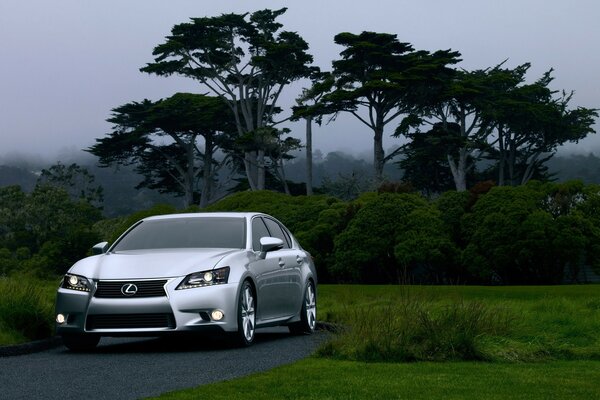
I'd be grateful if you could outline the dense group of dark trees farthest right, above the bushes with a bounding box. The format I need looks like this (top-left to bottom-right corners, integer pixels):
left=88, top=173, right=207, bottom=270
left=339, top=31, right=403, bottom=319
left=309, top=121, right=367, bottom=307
left=395, top=63, right=597, bottom=191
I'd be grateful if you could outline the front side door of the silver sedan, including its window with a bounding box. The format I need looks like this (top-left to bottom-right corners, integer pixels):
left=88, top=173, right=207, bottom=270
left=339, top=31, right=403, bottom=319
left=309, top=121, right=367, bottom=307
left=250, top=217, right=281, bottom=321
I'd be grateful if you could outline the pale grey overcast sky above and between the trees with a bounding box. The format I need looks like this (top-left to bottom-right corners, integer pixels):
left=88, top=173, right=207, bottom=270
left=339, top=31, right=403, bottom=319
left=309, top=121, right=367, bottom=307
left=0, top=0, right=600, bottom=162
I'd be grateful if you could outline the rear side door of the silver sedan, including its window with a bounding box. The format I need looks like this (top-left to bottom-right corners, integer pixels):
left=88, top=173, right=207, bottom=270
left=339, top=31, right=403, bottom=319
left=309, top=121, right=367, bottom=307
left=263, top=217, right=303, bottom=317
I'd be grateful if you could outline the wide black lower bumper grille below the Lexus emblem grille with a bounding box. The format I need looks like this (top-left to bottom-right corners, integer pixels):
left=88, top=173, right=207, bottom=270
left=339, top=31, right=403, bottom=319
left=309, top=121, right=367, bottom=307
left=85, top=314, right=176, bottom=331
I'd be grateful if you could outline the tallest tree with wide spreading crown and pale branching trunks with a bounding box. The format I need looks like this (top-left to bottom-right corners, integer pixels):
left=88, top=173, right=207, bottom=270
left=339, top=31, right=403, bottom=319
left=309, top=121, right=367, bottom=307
left=141, top=8, right=314, bottom=189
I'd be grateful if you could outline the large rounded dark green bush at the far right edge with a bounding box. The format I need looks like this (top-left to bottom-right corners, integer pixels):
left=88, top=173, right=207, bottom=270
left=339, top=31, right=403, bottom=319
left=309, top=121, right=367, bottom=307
left=462, top=182, right=600, bottom=285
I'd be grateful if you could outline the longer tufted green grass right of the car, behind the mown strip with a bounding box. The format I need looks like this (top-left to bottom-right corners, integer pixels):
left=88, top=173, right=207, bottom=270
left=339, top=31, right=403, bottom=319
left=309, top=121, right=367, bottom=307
left=319, top=285, right=600, bottom=362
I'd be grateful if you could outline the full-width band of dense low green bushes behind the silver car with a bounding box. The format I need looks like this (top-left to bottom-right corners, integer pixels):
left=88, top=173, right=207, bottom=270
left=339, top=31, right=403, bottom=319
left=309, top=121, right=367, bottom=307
left=0, top=181, right=600, bottom=284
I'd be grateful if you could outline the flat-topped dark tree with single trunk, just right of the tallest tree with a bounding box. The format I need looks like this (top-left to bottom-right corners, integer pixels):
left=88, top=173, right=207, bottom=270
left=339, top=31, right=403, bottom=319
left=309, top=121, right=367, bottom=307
left=323, top=32, right=460, bottom=181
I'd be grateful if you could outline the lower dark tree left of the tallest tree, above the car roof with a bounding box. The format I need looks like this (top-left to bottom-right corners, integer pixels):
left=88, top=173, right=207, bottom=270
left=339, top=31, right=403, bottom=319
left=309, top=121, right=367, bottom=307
left=88, top=93, right=235, bottom=206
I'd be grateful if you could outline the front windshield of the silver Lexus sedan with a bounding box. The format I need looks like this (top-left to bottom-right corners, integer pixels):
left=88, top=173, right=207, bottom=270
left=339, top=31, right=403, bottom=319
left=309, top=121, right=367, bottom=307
left=112, top=217, right=246, bottom=251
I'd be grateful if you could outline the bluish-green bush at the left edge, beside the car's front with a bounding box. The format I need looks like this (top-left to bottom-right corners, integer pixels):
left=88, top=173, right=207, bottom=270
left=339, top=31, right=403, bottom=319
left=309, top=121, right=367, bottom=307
left=0, top=186, right=101, bottom=277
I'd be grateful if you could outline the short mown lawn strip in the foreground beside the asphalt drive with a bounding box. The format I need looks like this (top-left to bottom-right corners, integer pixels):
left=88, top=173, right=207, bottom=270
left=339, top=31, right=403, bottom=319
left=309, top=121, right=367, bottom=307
left=152, top=358, right=600, bottom=400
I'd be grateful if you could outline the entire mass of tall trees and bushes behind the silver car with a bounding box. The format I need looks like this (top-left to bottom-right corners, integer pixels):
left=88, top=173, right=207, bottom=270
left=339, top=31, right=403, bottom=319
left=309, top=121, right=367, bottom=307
left=0, top=8, right=600, bottom=284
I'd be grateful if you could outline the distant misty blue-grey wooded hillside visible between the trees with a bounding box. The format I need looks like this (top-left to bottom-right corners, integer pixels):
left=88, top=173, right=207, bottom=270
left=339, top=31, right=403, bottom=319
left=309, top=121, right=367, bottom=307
left=0, top=151, right=600, bottom=217
